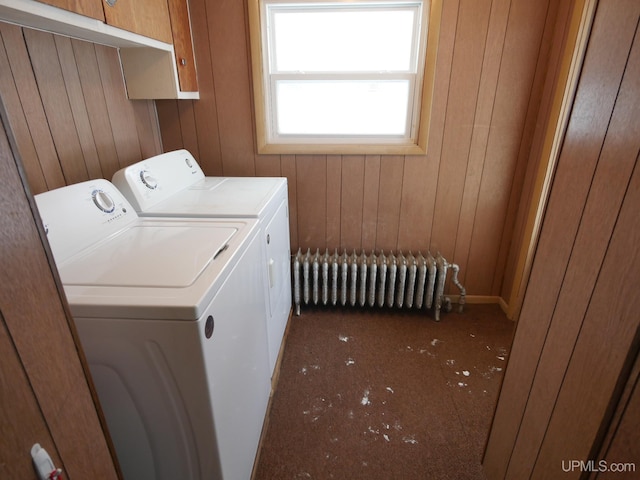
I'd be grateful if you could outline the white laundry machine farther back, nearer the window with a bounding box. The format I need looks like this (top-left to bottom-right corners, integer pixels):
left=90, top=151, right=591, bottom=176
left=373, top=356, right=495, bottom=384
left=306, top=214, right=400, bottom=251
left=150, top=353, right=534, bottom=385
left=112, top=149, right=291, bottom=374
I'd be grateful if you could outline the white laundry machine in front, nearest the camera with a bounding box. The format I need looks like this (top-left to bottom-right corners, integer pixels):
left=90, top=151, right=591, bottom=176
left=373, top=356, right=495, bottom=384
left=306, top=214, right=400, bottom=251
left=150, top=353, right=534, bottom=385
left=35, top=180, right=271, bottom=480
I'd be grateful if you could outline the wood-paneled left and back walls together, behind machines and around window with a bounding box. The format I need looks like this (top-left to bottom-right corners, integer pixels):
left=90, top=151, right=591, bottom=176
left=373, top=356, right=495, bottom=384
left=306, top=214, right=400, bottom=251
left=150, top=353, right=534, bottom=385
left=0, top=0, right=571, bottom=297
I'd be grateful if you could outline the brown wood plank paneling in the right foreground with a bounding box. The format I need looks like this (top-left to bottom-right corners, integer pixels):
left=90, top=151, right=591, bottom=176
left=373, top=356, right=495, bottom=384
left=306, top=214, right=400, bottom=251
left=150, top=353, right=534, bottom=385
left=484, top=0, right=640, bottom=480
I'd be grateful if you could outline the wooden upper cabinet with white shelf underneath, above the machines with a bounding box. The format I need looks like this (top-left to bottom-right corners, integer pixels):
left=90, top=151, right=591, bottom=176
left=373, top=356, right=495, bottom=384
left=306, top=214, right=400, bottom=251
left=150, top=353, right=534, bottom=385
left=0, top=0, right=199, bottom=100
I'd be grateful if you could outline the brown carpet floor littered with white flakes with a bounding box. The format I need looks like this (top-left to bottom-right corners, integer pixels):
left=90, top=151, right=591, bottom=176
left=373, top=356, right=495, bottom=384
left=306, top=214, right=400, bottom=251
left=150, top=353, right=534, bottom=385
left=254, top=305, right=514, bottom=480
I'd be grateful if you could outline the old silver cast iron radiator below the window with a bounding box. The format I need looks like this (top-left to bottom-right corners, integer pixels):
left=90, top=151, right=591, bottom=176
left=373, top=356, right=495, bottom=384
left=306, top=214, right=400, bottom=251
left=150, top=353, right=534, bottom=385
left=292, top=249, right=466, bottom=320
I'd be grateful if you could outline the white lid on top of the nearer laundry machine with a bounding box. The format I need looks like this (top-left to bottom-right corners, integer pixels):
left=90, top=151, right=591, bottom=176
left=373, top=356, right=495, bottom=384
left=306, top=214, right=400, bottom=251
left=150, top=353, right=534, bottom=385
left=59, top=224, right=237, bottom=288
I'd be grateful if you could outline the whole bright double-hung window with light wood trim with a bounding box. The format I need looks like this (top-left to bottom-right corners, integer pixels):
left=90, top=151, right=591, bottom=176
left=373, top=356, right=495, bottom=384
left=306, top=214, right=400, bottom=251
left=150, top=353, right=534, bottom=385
left=250, top=0, right=440, bottom=154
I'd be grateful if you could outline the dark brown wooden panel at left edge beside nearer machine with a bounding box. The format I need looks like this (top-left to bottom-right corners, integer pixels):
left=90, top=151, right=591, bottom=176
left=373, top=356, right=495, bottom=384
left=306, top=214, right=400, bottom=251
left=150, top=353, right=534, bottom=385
left=0, top=98, right=119, bottom=480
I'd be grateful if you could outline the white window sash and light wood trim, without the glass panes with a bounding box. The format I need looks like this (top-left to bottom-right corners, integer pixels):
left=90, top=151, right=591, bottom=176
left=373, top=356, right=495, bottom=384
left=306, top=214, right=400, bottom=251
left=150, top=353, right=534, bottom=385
left=249, top=0, right=441, bottom=155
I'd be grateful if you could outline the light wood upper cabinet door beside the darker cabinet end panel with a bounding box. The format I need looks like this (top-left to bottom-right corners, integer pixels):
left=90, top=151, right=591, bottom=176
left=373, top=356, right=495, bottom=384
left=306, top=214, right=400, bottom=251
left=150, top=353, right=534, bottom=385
left=103, top=0, right=173, bottom=43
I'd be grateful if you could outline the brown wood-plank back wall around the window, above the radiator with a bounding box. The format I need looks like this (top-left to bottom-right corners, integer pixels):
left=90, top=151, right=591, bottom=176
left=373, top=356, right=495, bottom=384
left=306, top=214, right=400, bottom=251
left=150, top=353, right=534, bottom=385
left=156, top=0, right=570, bottom=296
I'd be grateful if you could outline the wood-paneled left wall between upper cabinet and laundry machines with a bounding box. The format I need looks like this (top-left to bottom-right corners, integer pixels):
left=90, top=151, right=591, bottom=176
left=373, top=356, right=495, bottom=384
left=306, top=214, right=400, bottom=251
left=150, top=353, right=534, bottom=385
left=0, top=22, right=162, bottom=194
